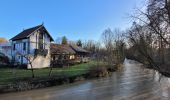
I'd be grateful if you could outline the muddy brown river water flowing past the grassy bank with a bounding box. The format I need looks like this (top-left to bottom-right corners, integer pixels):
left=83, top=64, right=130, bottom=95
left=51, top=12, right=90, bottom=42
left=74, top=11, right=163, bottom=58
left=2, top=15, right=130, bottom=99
left=0, top=60, right=170, bottom=100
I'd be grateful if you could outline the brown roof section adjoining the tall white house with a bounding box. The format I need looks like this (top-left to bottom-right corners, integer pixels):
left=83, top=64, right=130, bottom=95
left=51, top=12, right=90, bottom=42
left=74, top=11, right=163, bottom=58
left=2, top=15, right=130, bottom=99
left=50, top=44, right=75, bottom=54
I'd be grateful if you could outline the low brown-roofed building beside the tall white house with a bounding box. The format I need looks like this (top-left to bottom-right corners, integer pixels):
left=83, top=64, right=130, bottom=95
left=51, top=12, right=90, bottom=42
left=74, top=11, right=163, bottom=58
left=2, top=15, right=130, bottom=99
left=50, top=44, right=89, bottom=67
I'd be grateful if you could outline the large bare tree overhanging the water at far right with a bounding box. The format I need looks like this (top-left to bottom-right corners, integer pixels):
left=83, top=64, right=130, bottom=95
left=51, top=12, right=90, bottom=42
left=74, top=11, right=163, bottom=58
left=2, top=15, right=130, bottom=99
left=128, top=0, right=170, bottom=74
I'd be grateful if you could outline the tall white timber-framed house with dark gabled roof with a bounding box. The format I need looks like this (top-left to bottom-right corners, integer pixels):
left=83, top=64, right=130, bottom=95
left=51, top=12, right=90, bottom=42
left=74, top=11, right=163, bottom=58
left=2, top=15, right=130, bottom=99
left=11, top=25, right=53, bottom=69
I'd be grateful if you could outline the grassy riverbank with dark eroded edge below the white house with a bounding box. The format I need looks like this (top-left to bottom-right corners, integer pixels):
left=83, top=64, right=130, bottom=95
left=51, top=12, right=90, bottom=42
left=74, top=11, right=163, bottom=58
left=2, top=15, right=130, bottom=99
left=0, top=62, right=114, bottom=93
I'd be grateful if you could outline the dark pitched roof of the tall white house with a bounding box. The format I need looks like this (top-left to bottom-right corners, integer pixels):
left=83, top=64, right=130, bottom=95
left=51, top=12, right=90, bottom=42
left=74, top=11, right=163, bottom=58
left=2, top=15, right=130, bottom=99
left=11, top=25, right=53, bottom=41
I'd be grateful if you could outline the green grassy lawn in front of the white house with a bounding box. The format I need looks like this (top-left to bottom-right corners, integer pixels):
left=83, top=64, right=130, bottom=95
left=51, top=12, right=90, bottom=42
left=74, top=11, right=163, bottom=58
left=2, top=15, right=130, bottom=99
left=0, top=61, right=103, bottom=85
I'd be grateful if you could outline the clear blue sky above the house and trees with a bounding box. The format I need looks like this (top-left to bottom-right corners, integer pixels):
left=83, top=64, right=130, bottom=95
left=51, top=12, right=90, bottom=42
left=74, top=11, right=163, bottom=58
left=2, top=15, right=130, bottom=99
left=0, top=0, right=143, bottom=41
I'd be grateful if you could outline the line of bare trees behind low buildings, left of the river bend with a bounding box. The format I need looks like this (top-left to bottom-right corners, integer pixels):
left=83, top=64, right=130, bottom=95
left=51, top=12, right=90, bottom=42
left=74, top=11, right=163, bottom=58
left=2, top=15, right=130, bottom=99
left=56, top=28, right=126, bottom=70
